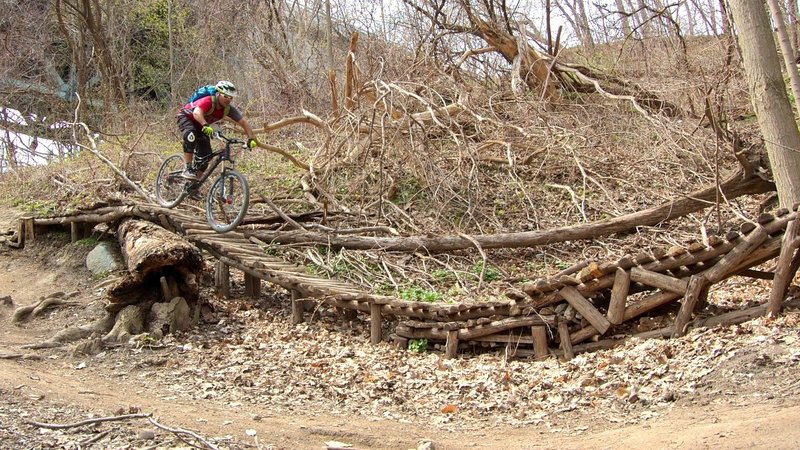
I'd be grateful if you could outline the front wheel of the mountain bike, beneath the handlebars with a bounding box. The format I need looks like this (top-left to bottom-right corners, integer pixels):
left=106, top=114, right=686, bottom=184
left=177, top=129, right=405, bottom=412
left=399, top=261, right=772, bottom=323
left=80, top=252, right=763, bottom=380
left=206, top=170, right=250, bottom=233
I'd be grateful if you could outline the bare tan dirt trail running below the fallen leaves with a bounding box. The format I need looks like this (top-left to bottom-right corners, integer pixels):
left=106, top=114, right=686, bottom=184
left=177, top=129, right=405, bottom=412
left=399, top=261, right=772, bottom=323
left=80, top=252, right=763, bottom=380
left=0, top=352, right=800, bottom=450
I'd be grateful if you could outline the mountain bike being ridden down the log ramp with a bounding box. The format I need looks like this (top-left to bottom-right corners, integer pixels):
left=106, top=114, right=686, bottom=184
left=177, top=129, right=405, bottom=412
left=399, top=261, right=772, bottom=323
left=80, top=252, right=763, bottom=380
left=156, top=132, right=250, bottom=233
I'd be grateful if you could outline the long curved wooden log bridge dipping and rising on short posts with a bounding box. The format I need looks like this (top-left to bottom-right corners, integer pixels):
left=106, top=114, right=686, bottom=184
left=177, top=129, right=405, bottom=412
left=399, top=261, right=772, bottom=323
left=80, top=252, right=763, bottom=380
left=7, top=204, right=800, bottom=359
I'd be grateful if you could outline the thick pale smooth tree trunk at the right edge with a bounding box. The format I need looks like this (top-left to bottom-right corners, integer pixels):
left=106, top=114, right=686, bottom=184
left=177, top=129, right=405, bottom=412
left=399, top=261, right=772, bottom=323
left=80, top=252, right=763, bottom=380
left=730, top=0, right=800, bottom=207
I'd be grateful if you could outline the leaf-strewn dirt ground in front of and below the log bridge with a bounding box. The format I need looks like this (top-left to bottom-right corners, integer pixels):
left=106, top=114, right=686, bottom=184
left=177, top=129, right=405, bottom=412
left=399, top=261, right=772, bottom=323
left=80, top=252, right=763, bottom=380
left=0, top=216, right=800, bottom=449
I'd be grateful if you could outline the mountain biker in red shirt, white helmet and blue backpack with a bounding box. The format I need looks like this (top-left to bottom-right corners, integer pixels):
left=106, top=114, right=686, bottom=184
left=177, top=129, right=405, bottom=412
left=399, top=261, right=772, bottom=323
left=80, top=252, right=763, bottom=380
left=177, top=80, right=258, bottom=180
